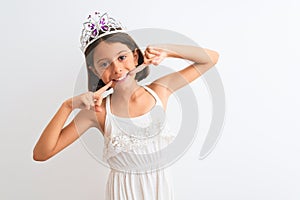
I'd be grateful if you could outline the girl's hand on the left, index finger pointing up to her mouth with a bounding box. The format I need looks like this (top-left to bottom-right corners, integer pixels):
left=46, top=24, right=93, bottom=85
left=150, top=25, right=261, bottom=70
left=67, top=81, right=112, bottom=112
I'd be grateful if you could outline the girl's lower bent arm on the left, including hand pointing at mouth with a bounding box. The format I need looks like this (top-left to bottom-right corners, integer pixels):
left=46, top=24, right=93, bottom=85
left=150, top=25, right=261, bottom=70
left=33, top=82, right=111, bottom=161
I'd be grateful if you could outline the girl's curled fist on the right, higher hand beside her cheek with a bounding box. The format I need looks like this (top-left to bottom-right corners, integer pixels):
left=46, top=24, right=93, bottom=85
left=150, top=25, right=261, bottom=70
left=144, top=46, right=168, bottom=66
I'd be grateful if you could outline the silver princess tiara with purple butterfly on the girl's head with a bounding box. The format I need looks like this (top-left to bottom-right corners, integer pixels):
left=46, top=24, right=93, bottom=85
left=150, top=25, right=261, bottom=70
left=80, top=12, right=125, bottom=52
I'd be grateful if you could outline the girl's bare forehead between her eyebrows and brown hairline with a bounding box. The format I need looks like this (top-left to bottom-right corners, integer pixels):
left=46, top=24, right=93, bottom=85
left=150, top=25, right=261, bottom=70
left=94, top=41, right=130, bottom=59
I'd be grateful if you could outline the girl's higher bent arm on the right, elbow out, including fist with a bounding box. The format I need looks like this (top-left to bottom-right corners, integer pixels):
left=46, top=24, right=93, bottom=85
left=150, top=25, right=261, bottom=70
left=145, top=44, right=219, bottom=99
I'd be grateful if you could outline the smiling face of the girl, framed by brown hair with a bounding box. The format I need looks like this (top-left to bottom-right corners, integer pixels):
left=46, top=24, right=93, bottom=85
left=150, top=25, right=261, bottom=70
left=90, top=41, right=138, bottom=87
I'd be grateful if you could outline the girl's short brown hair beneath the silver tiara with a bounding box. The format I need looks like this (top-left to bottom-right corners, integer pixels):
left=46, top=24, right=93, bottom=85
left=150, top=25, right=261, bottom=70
left=84, top=32, right=149, bottom=92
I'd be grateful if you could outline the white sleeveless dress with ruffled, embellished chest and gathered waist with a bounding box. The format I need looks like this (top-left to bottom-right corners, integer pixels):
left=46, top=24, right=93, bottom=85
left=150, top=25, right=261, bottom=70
left=103, top=86, right=174, bottom=200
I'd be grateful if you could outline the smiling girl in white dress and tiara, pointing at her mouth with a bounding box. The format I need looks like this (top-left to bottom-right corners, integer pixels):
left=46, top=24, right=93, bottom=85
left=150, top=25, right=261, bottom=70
left=33, top=12, right=218, bottom=200
